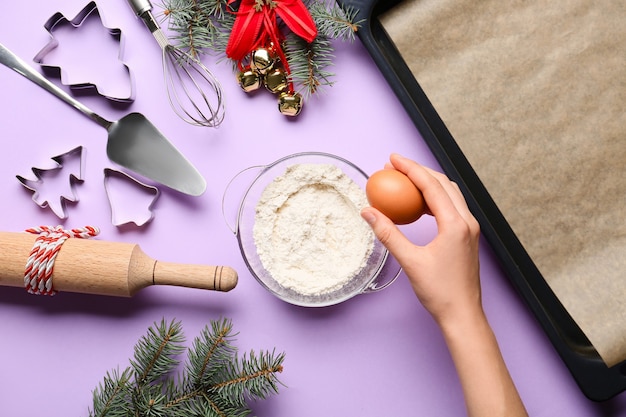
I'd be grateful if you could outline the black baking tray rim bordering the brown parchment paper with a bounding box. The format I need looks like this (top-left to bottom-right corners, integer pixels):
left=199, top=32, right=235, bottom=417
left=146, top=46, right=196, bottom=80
left=336, top=0, right=626, bottom=401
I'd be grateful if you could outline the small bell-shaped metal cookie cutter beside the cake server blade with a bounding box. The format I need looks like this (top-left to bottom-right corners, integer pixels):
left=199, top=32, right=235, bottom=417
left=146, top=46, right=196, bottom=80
left=104, top=168, right=160, bottom=227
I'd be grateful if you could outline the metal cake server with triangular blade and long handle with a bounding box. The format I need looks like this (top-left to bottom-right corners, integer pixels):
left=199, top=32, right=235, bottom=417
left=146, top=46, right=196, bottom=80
left=0, top=43, right=206, bottom=196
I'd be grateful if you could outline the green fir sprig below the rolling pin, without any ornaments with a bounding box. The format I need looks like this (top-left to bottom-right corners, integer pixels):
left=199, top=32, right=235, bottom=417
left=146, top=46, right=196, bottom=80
left=89, top=319, right=285, bottom=417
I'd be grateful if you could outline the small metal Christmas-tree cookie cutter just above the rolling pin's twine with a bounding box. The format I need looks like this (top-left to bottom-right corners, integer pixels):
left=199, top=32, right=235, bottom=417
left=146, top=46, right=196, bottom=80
left=15, top=146, right=84, bottom=219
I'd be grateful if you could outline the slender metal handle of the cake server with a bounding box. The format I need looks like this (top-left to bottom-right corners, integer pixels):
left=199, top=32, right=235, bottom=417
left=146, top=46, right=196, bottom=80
left=0, top=43, right=112, bottom=129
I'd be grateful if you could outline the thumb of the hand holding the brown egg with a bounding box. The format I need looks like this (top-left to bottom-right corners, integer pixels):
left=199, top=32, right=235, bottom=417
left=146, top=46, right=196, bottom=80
left=361, top=207, right=415, bottom=265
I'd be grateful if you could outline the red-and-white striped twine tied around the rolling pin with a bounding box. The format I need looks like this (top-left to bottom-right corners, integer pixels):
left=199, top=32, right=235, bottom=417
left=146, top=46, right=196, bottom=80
left=24, top=226, right=100, bottom=295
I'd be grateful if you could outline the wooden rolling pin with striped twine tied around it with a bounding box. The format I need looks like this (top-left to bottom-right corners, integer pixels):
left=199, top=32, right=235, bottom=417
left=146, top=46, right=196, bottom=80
left=0, top=232, right=237, bottom=297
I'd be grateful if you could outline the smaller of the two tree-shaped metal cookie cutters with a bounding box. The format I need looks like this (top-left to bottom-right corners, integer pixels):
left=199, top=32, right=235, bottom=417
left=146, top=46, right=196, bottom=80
left=16, top=146, right=84, bottom=219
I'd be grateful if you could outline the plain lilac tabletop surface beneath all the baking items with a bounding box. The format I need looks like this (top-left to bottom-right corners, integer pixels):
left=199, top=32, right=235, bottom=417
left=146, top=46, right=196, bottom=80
left=0, top=0, right=626, bottom=417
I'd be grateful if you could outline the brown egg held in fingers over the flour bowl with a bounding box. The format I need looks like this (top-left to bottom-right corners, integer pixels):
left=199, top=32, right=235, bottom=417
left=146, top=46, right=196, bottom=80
left=365, top=169, right=426, bottom=224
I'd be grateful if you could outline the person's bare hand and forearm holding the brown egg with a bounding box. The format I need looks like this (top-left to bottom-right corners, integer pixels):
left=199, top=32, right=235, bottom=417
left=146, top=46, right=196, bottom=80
left=361, top=154, right=528, bottom=417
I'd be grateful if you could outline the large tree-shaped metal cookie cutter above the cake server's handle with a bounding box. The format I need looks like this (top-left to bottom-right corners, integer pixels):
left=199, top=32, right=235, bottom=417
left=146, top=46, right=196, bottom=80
left=34, top=1, right=135, bottom=103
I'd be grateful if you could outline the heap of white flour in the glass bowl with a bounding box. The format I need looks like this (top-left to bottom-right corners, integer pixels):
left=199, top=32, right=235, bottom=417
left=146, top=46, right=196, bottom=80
left=253, top=164, right=374, bottom=295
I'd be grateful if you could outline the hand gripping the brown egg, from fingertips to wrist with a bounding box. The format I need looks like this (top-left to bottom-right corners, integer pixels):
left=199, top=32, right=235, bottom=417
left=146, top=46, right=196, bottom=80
left=361, top=154, right=482, bottom=325
